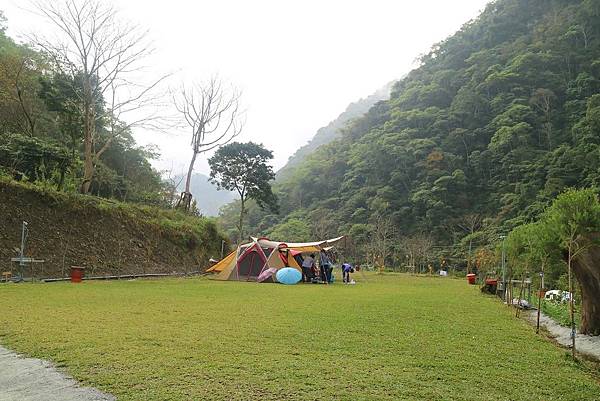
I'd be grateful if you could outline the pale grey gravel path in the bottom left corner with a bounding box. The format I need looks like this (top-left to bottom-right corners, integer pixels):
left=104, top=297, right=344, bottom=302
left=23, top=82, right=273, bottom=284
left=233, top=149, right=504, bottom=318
left=0, top=346, right=116, bottom=401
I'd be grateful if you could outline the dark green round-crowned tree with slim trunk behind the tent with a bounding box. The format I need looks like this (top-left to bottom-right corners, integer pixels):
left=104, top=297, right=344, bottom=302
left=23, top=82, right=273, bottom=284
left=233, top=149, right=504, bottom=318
left=208, top=142, right=277, bottom=242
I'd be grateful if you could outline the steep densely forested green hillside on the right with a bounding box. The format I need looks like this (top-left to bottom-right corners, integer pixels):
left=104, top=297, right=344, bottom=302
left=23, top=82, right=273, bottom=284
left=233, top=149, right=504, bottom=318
left=223, top=0, right=600, bottom=268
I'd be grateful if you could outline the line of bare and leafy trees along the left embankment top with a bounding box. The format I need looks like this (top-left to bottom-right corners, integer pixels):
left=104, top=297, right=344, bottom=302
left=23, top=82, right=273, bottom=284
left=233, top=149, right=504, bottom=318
left=0, top=0, right=276, bottom=222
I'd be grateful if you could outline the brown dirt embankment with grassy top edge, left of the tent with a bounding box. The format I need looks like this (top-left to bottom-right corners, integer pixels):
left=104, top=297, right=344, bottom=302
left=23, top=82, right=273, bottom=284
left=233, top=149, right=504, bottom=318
left=0, top=181, right=222, bottom=277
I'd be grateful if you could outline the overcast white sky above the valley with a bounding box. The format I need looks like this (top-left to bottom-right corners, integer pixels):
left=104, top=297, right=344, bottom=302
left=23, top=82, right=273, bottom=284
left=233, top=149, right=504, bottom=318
left=0, top=0, right=488, bottom=173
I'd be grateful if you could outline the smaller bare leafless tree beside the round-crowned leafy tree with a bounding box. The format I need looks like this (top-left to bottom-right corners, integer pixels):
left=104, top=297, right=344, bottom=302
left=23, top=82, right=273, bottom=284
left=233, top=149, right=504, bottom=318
left=173, top=76, right=243, bottom=210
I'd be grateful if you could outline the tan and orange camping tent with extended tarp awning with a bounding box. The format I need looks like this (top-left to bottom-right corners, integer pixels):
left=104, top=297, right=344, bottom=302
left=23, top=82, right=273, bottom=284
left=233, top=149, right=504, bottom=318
left=206, top=237, right=344, bottom=282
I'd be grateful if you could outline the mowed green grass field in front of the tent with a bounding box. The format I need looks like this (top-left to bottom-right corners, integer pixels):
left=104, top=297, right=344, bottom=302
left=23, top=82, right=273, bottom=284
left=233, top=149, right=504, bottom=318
left=0, top=274, right=600, bottom=400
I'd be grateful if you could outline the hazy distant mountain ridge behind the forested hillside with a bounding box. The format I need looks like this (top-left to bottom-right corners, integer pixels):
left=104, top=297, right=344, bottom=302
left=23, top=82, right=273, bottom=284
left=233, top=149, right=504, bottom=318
left=277, top=82, right=394, bottom=180
